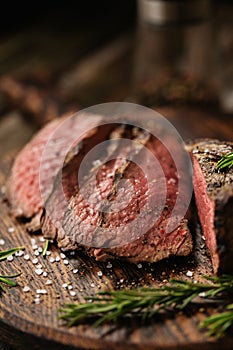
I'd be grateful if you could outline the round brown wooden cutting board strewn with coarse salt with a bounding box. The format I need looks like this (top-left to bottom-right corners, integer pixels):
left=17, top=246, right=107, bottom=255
left=0, top=154, right=233, bottom=350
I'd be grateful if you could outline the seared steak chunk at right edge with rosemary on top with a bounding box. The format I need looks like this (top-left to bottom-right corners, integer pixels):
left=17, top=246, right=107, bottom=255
left=187, top=139, right=233, bottom=273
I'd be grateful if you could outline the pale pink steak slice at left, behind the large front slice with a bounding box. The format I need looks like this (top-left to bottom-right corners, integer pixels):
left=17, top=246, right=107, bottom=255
left=6, top=114, right=101, bottom=230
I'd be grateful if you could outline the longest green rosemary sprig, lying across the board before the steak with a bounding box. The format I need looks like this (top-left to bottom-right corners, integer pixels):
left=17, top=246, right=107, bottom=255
left=59, top=275, right=233, bottom=335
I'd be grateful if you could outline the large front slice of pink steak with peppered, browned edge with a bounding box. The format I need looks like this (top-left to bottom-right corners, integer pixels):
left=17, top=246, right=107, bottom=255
left=42, top=124, right=192, bottom=263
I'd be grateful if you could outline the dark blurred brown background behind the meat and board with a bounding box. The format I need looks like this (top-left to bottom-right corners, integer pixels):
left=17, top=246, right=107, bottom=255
left=0, top=0, right=233, bottom=157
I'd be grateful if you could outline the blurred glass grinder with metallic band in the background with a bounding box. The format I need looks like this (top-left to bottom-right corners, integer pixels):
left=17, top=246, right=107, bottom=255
left=131, top=0, right=217, bottom=106
